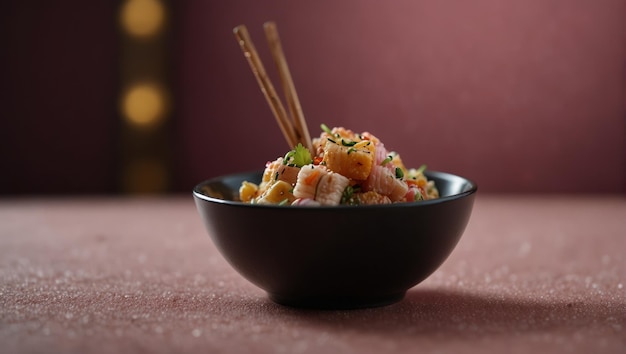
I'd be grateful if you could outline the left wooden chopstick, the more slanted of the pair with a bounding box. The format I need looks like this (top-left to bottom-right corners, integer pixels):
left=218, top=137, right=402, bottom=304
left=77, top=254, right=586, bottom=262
left=233, top=25, right=299, bottom=149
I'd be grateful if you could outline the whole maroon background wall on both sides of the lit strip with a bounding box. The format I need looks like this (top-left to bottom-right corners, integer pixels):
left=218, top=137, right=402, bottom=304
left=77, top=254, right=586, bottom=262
left=0, top=0, right=626, bottom=193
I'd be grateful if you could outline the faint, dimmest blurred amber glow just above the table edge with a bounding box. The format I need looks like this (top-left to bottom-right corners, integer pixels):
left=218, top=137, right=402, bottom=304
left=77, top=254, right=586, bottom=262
left=124, top=158, right=169, bottom=194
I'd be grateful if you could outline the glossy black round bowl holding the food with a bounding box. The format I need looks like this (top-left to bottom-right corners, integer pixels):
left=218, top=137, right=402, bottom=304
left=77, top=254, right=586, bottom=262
left=193, top=171, right=477, bottom=309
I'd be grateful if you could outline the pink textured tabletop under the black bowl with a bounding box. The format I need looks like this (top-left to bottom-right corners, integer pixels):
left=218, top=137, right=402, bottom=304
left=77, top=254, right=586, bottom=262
left=0, top=195, right=626, bottom=353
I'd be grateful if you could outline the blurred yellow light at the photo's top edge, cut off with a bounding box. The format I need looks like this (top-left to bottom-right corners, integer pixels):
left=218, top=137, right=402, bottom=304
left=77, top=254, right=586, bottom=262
left=120, top=0, right=165, bottom=37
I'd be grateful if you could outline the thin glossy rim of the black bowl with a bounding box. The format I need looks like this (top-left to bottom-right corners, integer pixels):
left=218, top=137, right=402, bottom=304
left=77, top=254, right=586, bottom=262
left=192, top=170, right=478, bottom=210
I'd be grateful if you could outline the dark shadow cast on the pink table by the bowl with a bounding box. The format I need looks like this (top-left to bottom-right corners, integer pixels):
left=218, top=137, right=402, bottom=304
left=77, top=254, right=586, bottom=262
left=265, top=289, right=626, bottom=337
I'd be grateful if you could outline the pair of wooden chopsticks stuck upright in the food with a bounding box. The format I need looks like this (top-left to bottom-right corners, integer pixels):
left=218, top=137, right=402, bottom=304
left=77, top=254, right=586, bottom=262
left=233, top=22, right=313, bottom=153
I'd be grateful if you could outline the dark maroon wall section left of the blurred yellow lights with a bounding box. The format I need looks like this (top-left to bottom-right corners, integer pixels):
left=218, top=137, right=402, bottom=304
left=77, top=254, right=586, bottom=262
left=0, top=0, right=118, bottom=194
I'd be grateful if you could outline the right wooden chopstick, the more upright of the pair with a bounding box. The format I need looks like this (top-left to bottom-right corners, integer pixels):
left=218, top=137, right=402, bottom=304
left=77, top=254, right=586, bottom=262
left=263, top=22, right=313, bottom=153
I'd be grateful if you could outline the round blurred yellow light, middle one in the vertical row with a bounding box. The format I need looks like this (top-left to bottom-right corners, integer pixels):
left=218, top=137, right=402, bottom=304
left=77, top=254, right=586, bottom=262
left=122, top=84, right=165, bottom=127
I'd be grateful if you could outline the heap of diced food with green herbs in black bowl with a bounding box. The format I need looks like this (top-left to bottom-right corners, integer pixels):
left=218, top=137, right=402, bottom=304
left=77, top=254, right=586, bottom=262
left=239, top=124, right=439, bottom=206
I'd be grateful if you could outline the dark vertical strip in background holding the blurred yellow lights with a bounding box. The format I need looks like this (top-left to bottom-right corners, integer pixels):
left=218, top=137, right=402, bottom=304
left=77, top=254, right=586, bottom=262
left=118, top=0, right=175, bottom=194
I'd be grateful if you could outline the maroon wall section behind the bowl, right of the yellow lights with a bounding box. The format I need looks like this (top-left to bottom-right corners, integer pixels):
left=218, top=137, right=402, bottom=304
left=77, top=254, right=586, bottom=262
left=172, top=0, right=626, bottom=193
